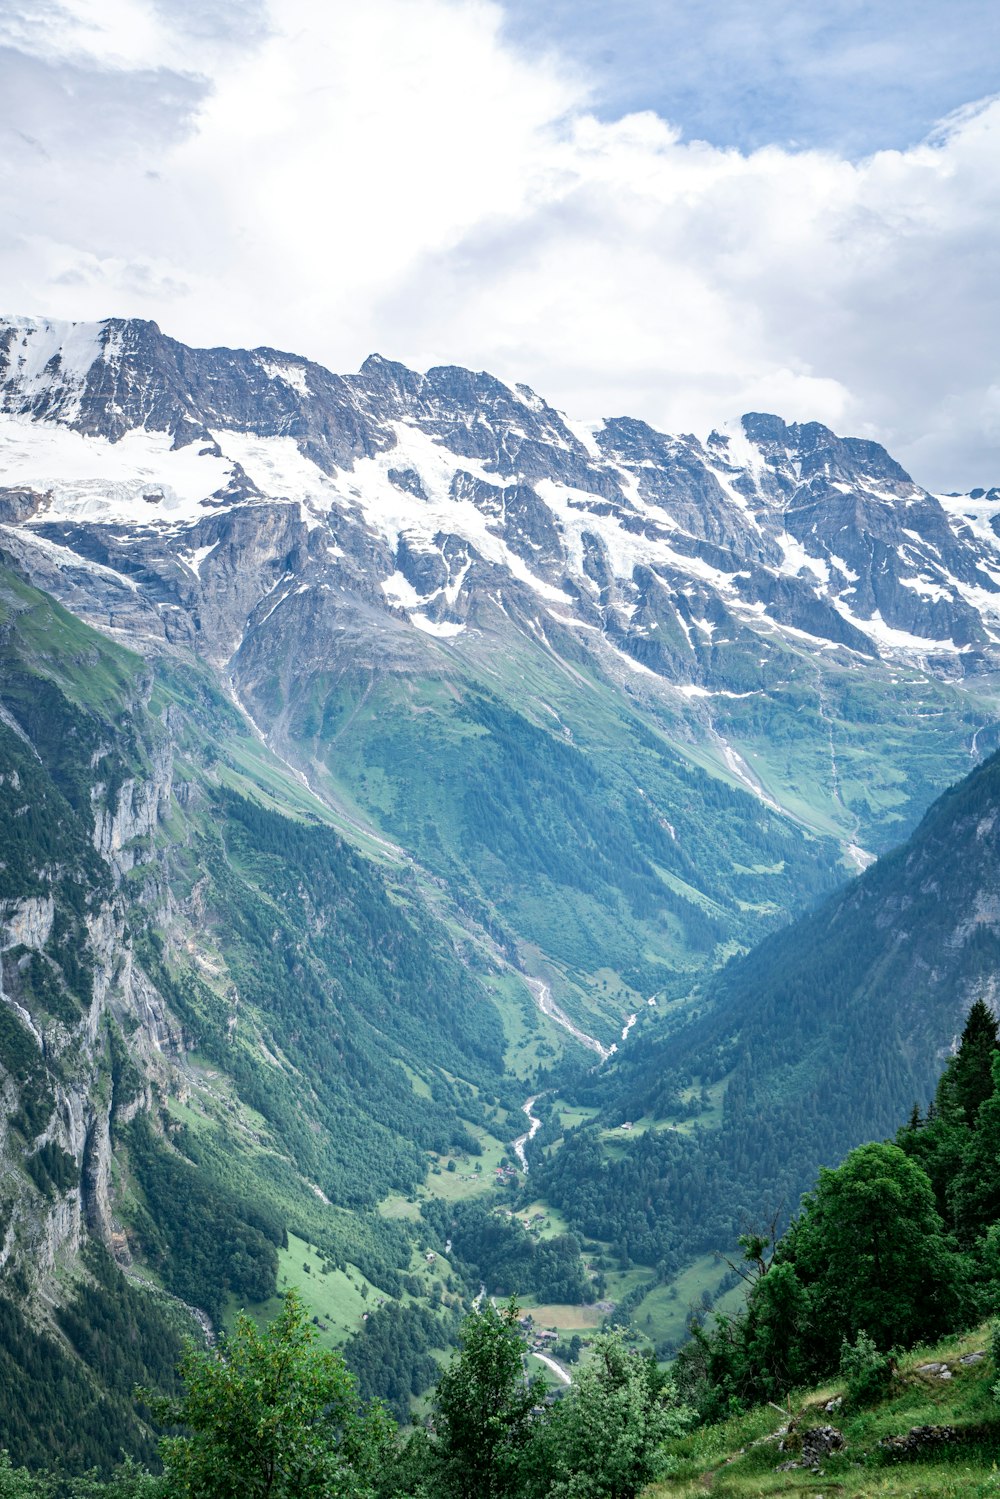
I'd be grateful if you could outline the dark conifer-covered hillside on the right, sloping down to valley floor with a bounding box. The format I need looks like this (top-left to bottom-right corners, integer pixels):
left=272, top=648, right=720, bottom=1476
left=532, top=743, right=1000, bottom=1319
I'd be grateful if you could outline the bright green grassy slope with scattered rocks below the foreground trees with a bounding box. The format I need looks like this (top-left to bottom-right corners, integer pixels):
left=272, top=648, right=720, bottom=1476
left=643, top=1328, right=1000, bottom=1499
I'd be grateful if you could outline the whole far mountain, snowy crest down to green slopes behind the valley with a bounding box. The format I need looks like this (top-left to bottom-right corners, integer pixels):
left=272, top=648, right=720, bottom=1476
left=0, top=319, right=1000, bottom=1043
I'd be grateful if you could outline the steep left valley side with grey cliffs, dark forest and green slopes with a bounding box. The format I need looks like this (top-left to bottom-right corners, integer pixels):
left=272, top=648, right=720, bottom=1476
left=0, top=559, right=517, bottom=1466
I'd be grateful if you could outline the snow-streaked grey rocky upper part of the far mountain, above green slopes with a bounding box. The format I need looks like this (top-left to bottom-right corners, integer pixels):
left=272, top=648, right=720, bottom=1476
left=0, top=319, right=1000, bottom=690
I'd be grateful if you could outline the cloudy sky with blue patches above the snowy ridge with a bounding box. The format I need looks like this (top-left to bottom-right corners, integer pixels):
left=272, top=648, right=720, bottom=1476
left=0, top=0, right=1000, bottom=490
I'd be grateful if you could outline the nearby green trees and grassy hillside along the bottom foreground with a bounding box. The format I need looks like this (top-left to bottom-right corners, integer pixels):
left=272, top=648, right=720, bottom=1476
left=9, top=1001, right=1000, bottom=1499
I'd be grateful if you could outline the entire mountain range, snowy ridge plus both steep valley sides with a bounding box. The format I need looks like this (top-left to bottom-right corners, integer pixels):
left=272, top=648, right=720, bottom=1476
left=0, top=319, right=1000, bottom=1462
